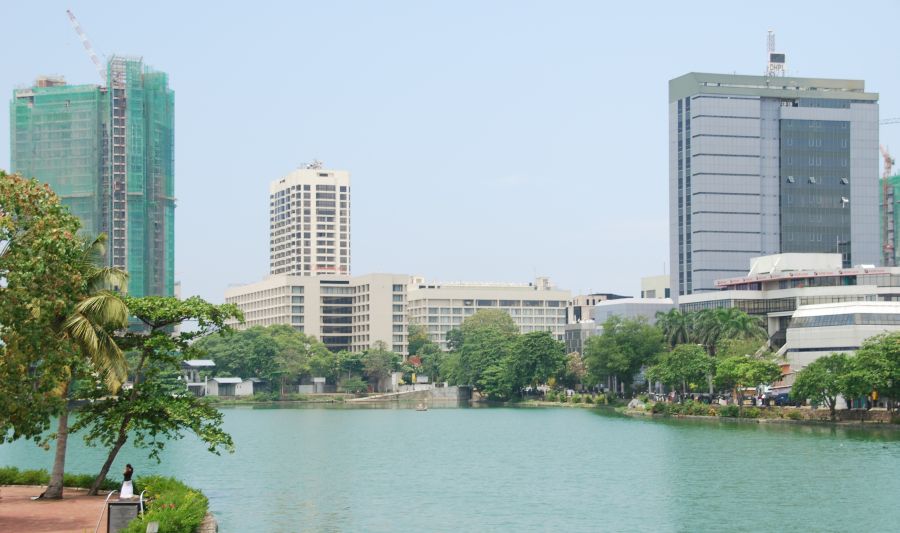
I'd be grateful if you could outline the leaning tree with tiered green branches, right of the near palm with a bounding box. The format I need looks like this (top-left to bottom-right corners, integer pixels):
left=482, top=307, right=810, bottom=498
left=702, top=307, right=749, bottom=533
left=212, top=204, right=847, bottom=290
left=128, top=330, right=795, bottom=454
left=74, top=296, right=243, bottom=494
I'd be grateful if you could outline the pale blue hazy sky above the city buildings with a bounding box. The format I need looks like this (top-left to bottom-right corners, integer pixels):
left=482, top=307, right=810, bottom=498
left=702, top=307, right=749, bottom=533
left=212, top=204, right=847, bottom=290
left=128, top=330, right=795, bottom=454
left=0, top=0, right=900, bottom=302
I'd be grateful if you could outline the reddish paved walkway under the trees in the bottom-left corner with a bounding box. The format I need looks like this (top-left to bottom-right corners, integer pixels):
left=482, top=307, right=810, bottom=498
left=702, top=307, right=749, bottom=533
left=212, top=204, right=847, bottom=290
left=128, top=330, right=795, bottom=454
left=0, top=485, right=115, bottom=533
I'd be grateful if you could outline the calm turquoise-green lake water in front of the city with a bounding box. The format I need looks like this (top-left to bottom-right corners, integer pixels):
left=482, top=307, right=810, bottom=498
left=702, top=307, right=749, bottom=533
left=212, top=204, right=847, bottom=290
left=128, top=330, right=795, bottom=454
left=0, top=407, right=900, bottom=532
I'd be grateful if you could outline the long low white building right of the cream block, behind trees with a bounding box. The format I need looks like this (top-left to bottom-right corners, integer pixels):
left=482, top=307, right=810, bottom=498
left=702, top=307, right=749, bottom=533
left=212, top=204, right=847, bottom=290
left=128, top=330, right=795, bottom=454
left=406, top=278, right=571, bottom=350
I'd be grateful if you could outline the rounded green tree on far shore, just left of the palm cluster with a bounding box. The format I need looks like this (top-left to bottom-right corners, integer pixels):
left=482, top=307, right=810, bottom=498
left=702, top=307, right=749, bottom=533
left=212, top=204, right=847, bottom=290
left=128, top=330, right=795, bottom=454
left=584, top=315, right=664, bottom=392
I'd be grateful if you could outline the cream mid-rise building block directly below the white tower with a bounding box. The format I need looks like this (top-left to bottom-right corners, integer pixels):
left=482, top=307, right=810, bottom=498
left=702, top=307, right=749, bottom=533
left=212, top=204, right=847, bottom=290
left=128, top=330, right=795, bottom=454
left=225, top=274, right=410, bottom=354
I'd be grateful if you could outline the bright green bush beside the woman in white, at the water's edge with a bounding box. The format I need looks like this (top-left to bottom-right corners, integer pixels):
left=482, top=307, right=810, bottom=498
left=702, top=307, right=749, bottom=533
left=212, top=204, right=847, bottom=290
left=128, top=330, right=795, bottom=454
left=121, top=476, right=209, bottom=533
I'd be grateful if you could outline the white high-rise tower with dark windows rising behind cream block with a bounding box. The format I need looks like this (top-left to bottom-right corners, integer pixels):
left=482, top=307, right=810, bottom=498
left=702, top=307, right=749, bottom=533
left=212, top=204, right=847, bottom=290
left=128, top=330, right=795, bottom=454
left=269, top=162, right=350, bottom=276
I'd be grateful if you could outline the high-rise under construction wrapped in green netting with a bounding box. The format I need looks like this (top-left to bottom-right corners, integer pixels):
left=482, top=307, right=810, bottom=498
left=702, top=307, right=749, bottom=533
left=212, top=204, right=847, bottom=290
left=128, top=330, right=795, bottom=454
left=10, top=56, right=175, bottom=296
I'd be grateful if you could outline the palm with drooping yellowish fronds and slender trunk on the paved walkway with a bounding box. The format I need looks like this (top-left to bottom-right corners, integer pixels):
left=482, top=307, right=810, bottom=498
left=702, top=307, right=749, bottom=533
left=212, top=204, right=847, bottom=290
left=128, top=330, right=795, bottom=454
left=41, top=233, right=128, bottom=499
